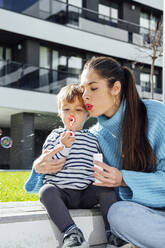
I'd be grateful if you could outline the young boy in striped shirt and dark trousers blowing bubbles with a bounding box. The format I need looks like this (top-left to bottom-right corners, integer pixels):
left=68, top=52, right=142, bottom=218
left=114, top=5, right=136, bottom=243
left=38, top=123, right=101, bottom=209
left=25, top=84, right=116, bottom=248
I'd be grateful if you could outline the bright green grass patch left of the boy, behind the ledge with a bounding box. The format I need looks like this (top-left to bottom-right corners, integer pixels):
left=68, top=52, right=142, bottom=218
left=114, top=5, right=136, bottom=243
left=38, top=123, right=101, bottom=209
left=0, top=171, right=39, bottom=202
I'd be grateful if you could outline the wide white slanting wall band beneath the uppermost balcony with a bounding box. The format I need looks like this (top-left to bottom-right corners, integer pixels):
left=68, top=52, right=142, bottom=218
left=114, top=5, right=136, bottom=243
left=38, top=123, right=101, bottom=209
left=0, top=9, right=162, bottom=67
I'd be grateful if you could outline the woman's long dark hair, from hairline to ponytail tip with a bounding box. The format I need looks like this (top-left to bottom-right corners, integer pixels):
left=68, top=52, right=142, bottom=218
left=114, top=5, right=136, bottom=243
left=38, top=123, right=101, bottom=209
left=84, top=57, right=156, bottom=172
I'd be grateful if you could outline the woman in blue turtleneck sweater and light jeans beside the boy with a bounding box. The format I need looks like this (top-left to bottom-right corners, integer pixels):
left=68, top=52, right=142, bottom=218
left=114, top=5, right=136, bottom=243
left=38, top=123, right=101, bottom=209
left=81, top=57, right=165, bottom=248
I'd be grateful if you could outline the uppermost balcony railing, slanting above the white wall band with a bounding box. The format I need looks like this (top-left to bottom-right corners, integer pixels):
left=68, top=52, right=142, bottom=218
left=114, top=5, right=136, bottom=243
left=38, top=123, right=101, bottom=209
left=0, top=0, right=153, bottom=46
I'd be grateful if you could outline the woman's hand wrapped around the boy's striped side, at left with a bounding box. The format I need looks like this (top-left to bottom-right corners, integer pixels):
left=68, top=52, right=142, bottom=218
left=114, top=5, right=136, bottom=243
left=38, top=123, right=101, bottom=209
left=34, top=146, right=66, bottom=174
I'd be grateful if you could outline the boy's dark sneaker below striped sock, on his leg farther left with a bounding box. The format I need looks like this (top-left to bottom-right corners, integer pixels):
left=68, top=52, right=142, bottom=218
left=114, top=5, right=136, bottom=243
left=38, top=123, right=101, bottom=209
left=62, top=228, right=89, bottom=248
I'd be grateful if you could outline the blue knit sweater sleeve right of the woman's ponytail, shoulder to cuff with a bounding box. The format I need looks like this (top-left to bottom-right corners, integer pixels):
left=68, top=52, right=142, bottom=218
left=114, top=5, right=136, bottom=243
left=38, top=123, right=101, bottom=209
left=119, top=103, right=165, bottom=208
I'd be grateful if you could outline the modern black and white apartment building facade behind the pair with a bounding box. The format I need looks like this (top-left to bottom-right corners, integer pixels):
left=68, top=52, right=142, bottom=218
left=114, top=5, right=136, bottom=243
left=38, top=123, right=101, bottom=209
left=0, top=0, right=163, bottom=169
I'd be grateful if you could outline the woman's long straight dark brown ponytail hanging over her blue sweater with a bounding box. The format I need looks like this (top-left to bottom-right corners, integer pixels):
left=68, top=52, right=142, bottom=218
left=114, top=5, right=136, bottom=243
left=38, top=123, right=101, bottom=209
left=122, top=67, right=156, bottom=172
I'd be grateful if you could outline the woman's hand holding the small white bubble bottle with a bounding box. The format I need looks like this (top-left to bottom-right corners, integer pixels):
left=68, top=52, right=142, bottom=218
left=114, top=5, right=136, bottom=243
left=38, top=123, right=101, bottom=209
left=93, top=161, right=127, bottom=187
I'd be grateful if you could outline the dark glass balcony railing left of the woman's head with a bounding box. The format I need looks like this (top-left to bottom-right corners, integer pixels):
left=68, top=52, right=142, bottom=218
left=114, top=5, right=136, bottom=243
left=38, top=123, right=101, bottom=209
left=0, top=60, right=79, bottom=94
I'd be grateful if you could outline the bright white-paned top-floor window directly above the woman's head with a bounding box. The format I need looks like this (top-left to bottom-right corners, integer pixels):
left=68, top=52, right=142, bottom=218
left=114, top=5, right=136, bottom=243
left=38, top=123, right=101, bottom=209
left=98, top=4, right=118, bottom=23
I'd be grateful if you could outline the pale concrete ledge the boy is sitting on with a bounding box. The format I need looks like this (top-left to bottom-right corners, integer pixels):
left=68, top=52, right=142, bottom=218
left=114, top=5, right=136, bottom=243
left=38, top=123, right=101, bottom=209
left=0, top=201, right=106, bottom=248
